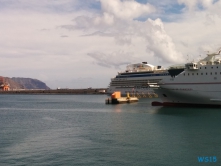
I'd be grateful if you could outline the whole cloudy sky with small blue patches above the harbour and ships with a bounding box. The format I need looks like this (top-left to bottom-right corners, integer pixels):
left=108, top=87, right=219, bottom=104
left=0, top=0, right=221, bottom=89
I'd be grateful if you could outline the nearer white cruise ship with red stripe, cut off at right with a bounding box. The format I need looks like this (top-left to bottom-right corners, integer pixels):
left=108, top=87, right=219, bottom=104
left=152, top=50, right=221, bottom=106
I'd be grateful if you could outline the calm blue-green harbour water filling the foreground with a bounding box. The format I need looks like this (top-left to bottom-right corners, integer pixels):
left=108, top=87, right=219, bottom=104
left=0, top=95, right=221, bottom=166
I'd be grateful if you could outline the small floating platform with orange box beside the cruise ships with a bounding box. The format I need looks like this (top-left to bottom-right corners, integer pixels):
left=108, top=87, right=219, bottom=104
left=105, top=92, right=139, bottom=104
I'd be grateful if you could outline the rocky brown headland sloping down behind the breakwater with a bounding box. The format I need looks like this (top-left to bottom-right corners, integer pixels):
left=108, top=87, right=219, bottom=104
left=4, top=77, right=50, bottom=89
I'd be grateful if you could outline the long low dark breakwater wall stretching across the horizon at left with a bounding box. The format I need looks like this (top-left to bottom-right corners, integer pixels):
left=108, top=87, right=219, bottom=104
left=0, top=88, right=107, bottom=94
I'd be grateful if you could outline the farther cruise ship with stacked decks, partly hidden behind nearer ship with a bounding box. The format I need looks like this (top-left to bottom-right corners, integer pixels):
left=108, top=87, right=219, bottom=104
left=107, top=62, right=169, bottom=96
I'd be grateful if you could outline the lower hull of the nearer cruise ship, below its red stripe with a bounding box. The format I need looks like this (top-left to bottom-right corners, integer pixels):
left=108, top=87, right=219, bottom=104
left=155, top=83, right=221, bottom=105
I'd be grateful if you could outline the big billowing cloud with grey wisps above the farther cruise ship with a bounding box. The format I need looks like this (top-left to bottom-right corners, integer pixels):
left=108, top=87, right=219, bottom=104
left=62, top=0, right=183, bottom=67
